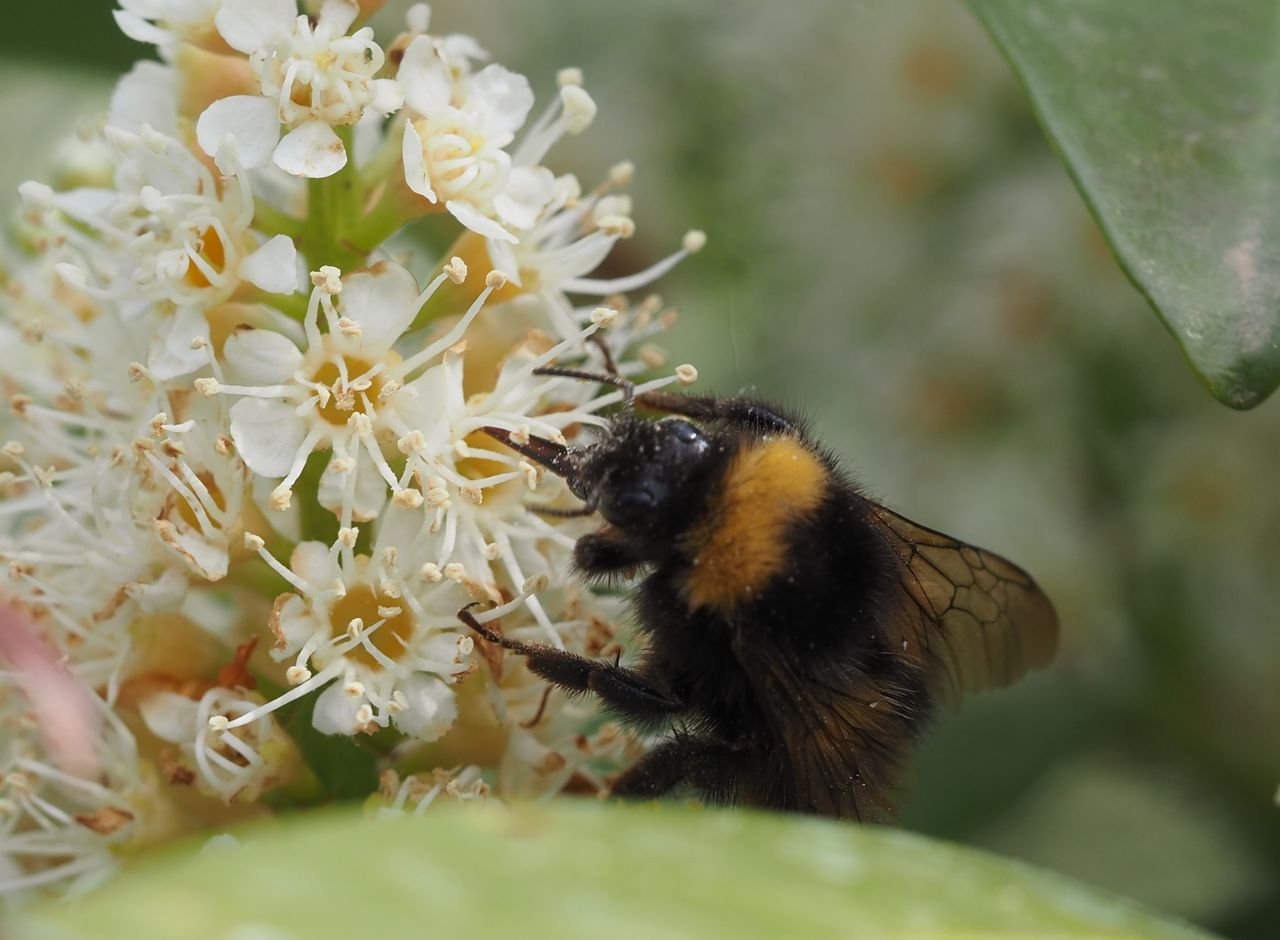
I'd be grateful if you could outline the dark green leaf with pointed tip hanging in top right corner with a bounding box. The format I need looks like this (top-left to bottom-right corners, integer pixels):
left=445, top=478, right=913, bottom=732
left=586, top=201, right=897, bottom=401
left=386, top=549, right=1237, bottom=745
left=968, top=0, right=1280, bottom=409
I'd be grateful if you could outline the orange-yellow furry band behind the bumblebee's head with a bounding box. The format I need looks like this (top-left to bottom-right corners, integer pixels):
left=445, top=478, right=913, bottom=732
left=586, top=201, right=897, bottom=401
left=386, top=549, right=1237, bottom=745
left=680, top=437, right=831, bottom=613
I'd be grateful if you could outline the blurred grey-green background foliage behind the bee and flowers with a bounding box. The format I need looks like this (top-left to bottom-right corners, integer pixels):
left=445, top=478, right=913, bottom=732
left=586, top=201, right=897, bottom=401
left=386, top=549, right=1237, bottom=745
left=0, top=0, right=1280, bottom=939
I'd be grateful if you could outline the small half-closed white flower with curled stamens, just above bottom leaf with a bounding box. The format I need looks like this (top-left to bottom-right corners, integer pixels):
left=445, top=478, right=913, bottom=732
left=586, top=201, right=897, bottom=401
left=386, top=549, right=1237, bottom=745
left=140, top=686, right=294, bottom=803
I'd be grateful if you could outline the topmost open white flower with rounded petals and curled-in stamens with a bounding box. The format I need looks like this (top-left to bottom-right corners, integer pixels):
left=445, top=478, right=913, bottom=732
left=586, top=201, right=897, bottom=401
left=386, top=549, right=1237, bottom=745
left=196, top=0, right=403, bottom=178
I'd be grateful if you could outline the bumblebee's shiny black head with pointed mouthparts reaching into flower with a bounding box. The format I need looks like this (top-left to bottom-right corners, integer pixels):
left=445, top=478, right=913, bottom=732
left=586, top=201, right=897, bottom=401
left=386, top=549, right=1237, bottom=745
left=485, top=414, right=716, bottom=538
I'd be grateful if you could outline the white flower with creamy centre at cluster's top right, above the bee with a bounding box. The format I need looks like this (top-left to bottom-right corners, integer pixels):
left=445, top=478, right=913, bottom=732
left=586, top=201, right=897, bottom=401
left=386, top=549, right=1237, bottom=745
left=398, top=36, right=595, bottom=242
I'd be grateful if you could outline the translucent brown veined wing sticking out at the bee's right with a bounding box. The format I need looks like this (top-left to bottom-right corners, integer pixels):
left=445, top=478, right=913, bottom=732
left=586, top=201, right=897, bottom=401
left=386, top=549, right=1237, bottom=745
left=868, top=502, right=1057, bottom=704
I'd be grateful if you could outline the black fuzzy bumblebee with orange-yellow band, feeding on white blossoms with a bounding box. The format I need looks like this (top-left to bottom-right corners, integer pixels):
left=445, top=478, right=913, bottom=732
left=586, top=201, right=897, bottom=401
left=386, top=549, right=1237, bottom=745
left=458, top=368, right=1059, bottom=820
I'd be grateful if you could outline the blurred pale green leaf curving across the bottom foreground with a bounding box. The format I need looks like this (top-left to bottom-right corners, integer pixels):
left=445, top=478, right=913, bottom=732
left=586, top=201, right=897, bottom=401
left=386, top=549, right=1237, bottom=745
left=14, top=802, right=1206, bottom=940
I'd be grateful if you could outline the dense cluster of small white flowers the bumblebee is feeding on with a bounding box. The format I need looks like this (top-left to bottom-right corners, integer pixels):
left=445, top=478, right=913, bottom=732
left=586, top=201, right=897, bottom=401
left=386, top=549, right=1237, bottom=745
left=0, top=0, right=703, bottom=911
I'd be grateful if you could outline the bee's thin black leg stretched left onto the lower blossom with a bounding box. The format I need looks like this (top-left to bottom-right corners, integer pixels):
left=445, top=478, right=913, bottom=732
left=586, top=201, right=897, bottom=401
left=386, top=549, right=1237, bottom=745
left=458, top=606, right=685, bottom=722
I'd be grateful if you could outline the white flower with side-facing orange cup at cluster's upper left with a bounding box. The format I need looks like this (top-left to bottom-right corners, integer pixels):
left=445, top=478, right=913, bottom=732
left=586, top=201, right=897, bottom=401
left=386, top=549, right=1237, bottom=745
left=20, top=128, right=297, bottom=379
